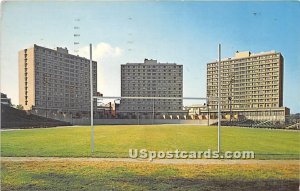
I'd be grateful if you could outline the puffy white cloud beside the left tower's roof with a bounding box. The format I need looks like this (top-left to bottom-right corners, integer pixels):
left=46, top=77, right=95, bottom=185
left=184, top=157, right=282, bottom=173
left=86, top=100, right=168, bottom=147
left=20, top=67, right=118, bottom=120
left=79, top=42, right=123, bottom=61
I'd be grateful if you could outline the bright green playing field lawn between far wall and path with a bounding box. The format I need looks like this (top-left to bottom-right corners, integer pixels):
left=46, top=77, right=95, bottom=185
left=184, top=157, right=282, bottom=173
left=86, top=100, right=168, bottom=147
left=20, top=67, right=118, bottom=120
left=1, top=125, right=300, bottom=159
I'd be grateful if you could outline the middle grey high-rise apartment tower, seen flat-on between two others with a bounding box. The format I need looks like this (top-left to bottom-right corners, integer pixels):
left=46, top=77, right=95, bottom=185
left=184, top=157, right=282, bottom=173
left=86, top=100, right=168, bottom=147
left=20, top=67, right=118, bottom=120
left=120, top=59, right=183, bottom=114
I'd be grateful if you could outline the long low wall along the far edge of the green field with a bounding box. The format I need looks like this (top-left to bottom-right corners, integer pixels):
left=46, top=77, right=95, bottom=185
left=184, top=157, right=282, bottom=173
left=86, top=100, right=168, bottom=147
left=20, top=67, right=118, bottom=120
left=72, top=119, right=217, bottom=125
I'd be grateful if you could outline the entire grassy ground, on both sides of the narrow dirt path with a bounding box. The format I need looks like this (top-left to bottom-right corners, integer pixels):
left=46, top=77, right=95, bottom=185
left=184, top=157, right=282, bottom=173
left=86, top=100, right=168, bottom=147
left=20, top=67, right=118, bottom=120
left=1, top=125, right=300, bottom=191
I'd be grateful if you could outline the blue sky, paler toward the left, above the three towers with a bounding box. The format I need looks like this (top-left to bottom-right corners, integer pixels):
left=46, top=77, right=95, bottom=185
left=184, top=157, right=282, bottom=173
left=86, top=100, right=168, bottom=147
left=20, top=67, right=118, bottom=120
left=0, top=1, right=300, bottom=113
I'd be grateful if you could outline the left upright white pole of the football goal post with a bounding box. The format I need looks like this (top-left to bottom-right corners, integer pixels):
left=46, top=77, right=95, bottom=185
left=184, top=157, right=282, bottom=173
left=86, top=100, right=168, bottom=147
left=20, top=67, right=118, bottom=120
left=90, top=44, right=94, bottom=153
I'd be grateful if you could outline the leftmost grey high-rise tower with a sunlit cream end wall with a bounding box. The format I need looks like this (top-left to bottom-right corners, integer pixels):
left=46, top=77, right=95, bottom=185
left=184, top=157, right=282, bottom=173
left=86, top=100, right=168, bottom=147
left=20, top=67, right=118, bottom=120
left=19, top=45, right=97, bottom=112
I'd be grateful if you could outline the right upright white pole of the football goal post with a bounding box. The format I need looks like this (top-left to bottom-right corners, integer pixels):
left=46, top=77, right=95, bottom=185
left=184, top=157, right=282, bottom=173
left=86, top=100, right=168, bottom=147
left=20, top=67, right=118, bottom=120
left=218, top=44, right=221, bottom=153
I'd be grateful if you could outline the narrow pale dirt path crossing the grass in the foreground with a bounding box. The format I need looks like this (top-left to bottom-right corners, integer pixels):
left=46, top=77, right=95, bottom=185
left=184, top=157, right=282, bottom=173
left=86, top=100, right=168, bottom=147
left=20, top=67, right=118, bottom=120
left=1, top=157, right=300, bottom=165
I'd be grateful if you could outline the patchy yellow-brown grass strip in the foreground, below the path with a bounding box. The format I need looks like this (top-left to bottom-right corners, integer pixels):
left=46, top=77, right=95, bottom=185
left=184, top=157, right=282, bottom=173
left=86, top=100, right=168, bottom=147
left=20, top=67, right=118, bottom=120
left=1, top=161, right=299, bottom=191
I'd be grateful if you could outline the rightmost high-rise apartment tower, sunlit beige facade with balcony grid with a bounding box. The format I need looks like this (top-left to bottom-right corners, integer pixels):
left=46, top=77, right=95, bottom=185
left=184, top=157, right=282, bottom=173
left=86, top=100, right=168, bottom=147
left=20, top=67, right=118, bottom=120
left=207, top=51, right=289, bottom=121
